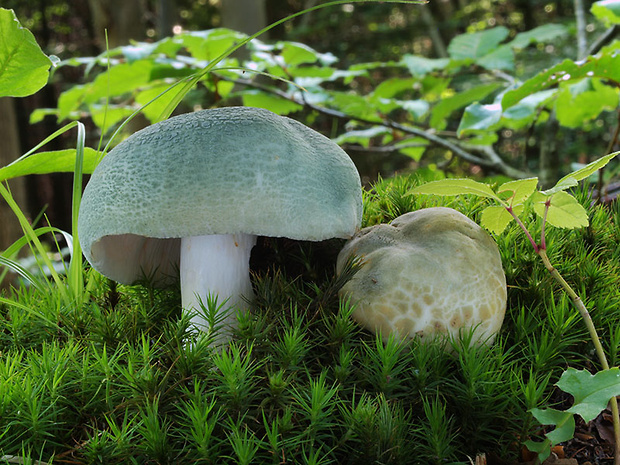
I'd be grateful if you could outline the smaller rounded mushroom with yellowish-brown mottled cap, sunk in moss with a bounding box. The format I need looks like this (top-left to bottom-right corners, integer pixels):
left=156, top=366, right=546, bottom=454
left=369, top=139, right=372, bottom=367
left=337, top=207, right=506, bottom=344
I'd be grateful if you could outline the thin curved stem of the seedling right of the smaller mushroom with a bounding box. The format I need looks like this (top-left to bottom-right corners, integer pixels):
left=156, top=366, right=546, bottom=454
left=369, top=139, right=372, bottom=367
left=538, top=248, right=620, bottom=465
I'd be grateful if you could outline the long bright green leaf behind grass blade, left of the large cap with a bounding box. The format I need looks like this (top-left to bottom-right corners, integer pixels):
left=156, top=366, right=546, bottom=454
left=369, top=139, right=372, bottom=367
left=0, top=147, right=100, bottom=181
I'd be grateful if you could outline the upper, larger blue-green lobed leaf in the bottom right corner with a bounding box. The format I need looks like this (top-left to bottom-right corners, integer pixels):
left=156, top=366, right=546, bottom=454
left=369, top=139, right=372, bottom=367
left=556, top=367, right=620, bottom=423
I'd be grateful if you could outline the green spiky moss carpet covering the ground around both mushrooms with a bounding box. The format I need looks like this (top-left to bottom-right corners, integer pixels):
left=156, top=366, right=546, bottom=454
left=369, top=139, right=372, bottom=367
left=0, top=177, right=620, bottom=465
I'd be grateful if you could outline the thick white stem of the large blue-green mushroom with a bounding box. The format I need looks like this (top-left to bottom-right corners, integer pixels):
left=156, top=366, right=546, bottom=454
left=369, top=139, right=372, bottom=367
left=180, top=234, right=256, bottom=340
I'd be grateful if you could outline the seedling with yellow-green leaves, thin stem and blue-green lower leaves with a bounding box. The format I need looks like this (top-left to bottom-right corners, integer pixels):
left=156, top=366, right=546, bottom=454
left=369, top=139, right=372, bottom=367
left=411, top=152, right=620, bottom=465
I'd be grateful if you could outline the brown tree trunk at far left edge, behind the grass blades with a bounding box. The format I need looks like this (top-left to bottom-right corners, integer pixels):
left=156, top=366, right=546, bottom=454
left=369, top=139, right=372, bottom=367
left=0, top=97, right=26, bottom=287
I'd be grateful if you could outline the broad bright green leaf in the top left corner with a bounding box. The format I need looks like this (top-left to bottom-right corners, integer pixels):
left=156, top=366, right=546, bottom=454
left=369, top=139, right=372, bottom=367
left=0, top=8, right=52, bottom=97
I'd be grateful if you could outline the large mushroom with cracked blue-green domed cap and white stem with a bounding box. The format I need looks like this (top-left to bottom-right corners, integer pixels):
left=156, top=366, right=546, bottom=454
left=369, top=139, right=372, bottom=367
left=78, top=107, right=362, bottom=340
